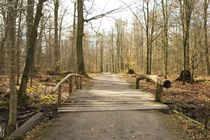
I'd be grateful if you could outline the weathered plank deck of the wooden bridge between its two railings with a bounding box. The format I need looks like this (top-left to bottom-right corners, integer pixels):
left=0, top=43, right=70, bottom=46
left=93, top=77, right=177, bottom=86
left=57, top=74, right=168, bottom=113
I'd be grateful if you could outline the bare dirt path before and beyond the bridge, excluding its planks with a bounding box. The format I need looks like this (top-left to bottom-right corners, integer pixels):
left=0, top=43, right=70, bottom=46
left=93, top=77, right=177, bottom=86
left=36, top=74, right=189, bottom=140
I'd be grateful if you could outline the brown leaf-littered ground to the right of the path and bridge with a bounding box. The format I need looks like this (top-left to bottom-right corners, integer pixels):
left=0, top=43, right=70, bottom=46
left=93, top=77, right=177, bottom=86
left=123, top=75, right=210, bottom=140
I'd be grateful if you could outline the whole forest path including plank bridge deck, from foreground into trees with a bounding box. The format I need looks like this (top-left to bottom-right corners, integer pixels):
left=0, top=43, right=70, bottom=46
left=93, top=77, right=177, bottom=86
left=36, top=74, right=188, bottom=140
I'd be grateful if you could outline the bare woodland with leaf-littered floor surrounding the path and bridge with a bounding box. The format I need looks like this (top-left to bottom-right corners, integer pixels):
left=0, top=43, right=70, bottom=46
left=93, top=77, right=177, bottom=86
left=0, top=0, right=210, bottom=139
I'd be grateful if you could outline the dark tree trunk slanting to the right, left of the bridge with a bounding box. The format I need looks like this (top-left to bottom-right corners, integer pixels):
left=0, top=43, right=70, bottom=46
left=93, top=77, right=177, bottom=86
left=19, top=0, right=46, bottom=104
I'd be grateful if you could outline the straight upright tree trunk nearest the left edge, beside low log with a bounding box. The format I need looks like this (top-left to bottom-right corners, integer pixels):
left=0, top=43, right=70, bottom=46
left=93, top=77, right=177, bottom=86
left=7, top=0, right=17, bottom=134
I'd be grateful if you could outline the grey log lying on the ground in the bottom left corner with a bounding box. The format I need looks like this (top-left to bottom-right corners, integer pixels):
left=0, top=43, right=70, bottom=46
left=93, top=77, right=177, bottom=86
left=6, top=112, right=44, bottom=139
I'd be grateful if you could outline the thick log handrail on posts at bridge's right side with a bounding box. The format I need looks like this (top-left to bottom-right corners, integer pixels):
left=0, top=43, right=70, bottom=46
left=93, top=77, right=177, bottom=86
left=136, top=75, right=171, bottom=102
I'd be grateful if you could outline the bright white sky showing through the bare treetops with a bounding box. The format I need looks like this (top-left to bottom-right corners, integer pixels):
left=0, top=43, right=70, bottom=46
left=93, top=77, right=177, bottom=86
left=62, top=0, right=133, bottom=32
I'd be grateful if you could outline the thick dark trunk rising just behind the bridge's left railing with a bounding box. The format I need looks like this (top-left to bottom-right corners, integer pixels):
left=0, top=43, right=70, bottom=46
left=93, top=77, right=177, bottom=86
left=76, top=0, right=86, bottom=75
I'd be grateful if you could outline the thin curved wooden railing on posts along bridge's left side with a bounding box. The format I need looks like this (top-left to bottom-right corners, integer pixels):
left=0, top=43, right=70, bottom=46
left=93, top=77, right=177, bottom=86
left=53, top=74, right=82, bottom=106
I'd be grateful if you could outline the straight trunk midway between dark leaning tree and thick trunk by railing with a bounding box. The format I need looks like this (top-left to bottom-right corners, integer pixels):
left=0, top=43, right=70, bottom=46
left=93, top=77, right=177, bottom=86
left=54, top=0, right=60, bottom=72
